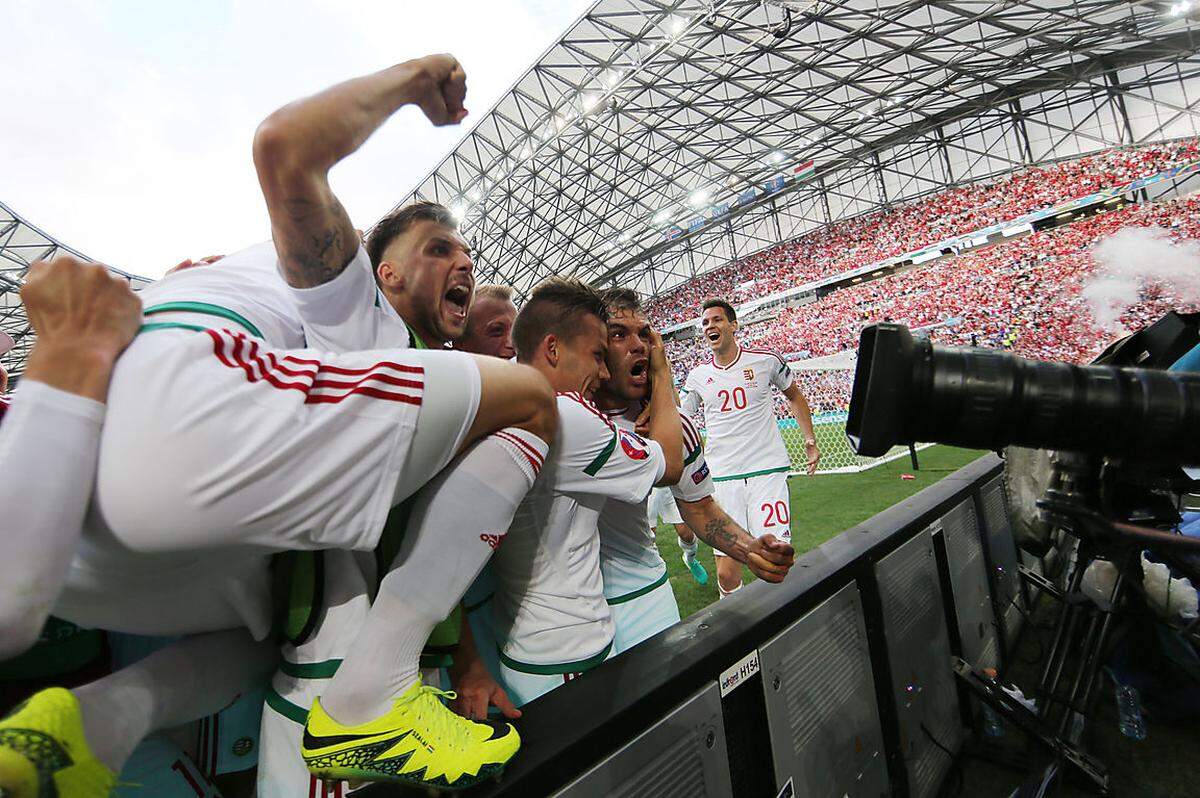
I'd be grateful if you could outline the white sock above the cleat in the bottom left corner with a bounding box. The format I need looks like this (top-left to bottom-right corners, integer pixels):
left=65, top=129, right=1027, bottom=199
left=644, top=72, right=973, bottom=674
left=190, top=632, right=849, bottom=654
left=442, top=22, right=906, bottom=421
left=71, top=629, right=280, bottom=773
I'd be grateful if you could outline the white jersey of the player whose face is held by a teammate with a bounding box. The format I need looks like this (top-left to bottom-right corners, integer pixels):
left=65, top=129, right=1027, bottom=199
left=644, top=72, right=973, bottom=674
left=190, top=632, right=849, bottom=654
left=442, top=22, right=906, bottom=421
left=600, top=404, right=713, bottom=599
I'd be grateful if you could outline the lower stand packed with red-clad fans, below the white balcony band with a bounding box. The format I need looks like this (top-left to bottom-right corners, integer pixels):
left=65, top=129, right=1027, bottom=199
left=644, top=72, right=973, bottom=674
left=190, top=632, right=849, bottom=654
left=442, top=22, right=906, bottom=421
left=671, top=196, right=1200, bottom=386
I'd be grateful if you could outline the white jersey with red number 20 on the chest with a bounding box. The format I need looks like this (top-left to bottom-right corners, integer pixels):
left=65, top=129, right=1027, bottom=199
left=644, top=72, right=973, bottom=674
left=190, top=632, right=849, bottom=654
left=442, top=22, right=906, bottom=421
left=680, top=348, right=794, bottom=480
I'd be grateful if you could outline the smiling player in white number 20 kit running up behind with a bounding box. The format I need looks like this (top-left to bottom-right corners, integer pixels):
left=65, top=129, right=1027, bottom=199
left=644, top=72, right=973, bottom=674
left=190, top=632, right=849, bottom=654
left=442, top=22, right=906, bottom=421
left=682, top=299, right=821, bottom=599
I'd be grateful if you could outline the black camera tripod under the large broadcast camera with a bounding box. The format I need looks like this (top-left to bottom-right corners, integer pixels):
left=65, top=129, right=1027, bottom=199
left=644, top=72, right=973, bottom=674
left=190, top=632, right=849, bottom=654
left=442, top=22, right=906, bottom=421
left=954, top=452, right=1200, bottom=798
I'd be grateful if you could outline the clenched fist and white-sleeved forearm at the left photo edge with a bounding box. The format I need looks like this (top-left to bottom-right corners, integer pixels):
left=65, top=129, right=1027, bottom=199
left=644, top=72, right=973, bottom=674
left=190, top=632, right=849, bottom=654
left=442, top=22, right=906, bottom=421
left=0, top=256, right=142, bottom=660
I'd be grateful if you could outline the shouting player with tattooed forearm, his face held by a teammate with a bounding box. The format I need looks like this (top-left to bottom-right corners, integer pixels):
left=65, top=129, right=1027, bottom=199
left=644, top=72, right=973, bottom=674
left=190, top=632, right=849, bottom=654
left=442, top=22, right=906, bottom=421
left=596, top=288, right=794, bottom=654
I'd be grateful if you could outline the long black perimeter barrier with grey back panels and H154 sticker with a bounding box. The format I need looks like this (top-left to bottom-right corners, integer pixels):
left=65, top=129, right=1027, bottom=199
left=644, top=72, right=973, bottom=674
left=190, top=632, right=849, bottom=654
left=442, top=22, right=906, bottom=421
left=355, top=455, right=1022, bottom=798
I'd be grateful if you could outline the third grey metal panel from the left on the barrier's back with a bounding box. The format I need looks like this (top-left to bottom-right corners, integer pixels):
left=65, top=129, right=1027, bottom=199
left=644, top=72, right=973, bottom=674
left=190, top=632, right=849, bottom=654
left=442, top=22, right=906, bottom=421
left=875, top=529, right=962, bottom=798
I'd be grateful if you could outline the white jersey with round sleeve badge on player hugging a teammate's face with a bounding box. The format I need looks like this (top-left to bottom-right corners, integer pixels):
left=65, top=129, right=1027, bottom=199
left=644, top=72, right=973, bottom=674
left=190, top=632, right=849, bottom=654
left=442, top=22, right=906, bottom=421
left=492, top=394, right=666, bottom=665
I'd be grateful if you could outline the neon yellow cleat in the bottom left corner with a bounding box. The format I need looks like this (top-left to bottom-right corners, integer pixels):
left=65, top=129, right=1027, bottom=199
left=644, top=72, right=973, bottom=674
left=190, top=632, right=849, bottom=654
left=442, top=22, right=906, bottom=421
left=0, top=688, right=116, bottom=798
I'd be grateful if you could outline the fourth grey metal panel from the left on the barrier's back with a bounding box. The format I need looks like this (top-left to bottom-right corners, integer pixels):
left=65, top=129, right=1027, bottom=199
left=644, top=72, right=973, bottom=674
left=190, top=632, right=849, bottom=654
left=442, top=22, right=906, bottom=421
left=931, top=498, right=1000, bottom=668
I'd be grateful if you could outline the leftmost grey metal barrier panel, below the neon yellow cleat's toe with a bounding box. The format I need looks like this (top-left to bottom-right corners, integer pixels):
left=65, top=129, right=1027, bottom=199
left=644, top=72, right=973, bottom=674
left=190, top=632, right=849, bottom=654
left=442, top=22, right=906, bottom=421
left=554, top=682, right=733, bottom=798
